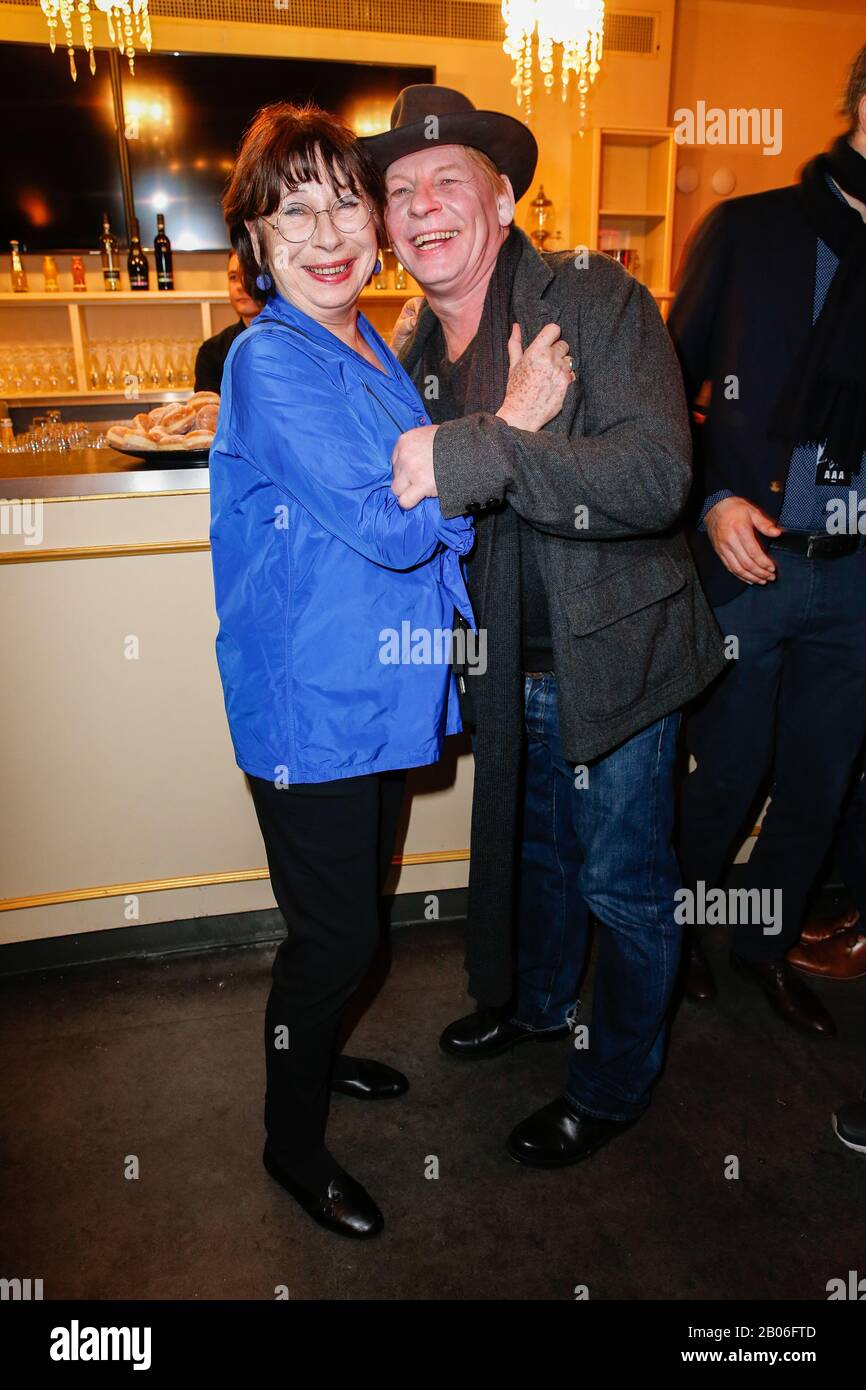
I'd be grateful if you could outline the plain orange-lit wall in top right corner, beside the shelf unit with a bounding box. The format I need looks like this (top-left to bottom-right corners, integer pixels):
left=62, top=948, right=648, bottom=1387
left=670, top=0, right=866, bottom=276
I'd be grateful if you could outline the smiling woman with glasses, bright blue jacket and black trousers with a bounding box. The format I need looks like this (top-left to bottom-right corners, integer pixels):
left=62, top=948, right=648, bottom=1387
left=210, top=103, right=474, bottom=1237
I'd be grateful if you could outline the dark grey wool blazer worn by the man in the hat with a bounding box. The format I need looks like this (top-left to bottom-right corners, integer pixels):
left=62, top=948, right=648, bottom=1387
left=400, top=232, right=724, bottom=763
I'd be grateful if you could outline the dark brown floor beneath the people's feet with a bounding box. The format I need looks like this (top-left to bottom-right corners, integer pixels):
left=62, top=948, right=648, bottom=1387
left=0, top=923, right=866, bottom=1300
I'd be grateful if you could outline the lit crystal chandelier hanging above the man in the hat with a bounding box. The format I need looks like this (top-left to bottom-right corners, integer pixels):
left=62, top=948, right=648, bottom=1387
left=502, top=0, right=605, bottom=125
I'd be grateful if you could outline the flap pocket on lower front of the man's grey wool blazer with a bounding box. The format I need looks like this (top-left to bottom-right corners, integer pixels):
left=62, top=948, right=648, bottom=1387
left=560, top=555, right=694, bottom=721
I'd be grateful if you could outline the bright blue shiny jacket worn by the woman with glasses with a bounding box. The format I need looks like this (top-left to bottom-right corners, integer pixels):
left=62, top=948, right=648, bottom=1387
left=210, top=295, right=474, bottom=783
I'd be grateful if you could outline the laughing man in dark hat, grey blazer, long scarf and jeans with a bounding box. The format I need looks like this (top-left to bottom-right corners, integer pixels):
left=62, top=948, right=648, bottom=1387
left=364, top=86, right=724, bottom=1166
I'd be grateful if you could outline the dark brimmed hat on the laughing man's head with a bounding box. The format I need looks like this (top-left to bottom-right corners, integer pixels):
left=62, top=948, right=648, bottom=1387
left=361, top=82, right=538, bottom=202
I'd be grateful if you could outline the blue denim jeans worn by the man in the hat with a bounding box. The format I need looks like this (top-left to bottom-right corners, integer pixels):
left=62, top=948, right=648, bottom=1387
left=513, top=676, right=683, bottom=1120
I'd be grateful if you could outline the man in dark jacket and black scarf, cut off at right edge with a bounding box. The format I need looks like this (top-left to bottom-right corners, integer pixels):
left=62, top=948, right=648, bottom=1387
left=669, top=47, right=866, bottom=1037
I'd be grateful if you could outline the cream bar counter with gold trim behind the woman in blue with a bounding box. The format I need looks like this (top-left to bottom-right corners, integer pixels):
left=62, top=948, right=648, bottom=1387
left=0, top=449, right=473, bottom=942
